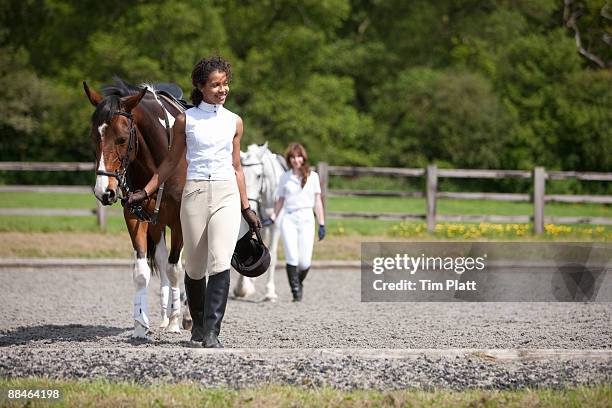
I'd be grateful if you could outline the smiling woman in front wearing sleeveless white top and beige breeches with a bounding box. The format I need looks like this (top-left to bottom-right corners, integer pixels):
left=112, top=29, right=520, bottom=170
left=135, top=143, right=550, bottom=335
left=128, top=57, right=261, bottom=348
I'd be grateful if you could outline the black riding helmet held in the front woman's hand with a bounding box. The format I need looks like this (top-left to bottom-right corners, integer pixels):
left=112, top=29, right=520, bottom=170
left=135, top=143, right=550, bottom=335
left=232, top=231, right=270, bottom=278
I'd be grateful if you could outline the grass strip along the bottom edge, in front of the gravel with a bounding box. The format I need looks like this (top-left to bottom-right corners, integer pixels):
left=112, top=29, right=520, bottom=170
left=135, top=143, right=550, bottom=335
left=0, top=378, right=612, bottom=408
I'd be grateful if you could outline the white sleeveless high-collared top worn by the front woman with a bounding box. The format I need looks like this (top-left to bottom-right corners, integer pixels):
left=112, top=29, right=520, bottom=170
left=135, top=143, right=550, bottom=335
left=185, top=101, right=238, bottom=180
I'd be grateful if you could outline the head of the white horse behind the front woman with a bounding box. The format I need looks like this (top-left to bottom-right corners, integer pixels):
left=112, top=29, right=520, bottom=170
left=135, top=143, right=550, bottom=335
left=240, top=142, right=284, bottom=218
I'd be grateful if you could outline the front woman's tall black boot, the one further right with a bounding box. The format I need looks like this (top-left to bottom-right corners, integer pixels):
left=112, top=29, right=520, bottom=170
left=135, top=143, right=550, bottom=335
left=202, top=269, right=230, bottom=348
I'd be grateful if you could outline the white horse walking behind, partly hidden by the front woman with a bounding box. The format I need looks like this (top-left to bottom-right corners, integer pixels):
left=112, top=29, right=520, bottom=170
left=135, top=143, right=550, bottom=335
left=234, top=142, right=287, bottom=302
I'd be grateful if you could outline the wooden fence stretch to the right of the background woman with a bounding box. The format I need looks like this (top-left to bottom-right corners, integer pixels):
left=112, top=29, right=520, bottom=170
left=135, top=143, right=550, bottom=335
left=317, top=163, right=612, bottom=234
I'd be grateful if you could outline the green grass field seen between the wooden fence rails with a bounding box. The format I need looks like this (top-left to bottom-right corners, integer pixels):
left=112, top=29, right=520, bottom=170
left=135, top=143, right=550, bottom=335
left=0, top=193, right=612, bottom=238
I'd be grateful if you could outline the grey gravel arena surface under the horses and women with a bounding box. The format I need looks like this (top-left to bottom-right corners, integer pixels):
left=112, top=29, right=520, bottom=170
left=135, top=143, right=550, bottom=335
left=0, top=265, right=612, bottom=390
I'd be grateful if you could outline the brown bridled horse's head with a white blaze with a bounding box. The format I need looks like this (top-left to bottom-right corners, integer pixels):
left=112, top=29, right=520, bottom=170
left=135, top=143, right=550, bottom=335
left=83, top=82, right=146, bottom=205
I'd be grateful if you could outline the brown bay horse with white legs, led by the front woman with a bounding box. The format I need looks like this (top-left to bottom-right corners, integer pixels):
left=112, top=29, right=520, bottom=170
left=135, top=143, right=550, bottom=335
left=83, top=78, right=191, bottom=338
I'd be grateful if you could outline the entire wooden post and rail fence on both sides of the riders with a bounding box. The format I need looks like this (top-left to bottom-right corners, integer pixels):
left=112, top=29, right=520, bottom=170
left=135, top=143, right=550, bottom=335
left=0, top=162, right=612, bottom=234
